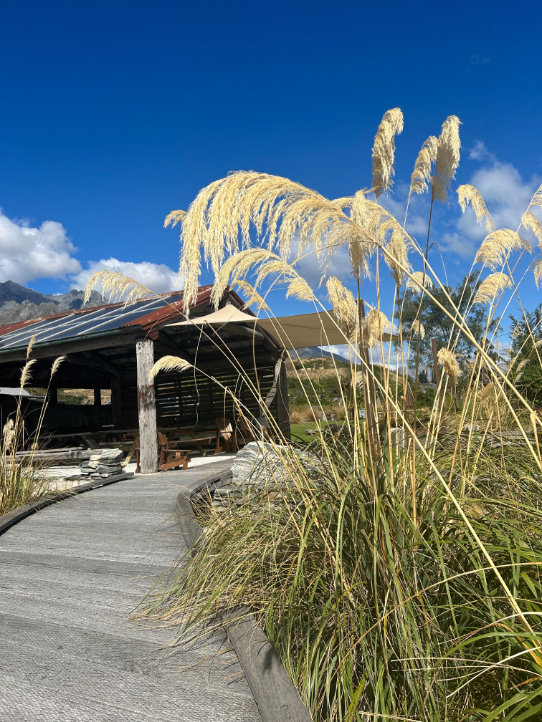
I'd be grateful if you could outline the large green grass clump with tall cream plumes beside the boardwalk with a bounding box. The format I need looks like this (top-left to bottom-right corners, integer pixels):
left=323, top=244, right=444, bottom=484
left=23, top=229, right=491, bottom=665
left=89, top=109, right=542, bottom=722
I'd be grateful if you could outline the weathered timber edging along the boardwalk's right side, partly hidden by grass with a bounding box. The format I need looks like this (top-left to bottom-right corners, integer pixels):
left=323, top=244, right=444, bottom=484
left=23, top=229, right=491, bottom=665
left=176, top=476, right=312, bottom=722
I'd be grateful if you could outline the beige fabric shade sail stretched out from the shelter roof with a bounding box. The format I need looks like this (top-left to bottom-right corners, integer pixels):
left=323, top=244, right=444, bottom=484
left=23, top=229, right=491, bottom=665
left=169, top=305, right=397, bottom=349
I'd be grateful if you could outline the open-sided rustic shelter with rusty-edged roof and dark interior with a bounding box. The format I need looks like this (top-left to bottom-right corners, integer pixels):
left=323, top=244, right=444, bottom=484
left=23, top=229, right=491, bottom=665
left=0, top=287, right=288, bottom=456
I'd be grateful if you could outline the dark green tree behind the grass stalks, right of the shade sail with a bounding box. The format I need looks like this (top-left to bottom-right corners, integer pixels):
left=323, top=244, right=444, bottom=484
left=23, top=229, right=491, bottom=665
left=397, top=274, right=499, bottom=366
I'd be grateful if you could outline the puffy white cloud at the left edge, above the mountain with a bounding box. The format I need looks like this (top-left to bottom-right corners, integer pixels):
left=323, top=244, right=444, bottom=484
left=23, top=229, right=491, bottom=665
left=0, top=210, right=81, bottom=284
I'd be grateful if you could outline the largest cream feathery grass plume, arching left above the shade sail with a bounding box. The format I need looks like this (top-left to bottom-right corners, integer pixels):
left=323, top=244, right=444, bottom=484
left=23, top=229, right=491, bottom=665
left=179, top=171, right=364, bottom=313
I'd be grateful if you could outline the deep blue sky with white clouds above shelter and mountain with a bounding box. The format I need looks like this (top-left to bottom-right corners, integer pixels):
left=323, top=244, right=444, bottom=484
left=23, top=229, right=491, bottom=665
left=0, top=0, right=542, bottom=320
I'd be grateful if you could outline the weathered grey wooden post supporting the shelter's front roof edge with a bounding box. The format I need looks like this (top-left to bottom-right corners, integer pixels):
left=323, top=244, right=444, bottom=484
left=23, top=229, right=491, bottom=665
left=136, top=338, right=158, bottom=474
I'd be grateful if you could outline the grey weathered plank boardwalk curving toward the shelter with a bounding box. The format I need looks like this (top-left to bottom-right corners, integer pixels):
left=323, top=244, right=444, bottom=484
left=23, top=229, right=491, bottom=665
left=0, top=460, right=261, bottom=722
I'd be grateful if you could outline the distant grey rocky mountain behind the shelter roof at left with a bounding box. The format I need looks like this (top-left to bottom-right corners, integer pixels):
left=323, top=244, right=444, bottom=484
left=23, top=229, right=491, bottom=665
left=0, top=281, right=105, bottom=325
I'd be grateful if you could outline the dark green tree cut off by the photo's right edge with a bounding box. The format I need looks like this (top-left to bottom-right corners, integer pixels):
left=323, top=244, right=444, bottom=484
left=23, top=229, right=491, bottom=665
left=510, top=303, right=542, bottom=406
